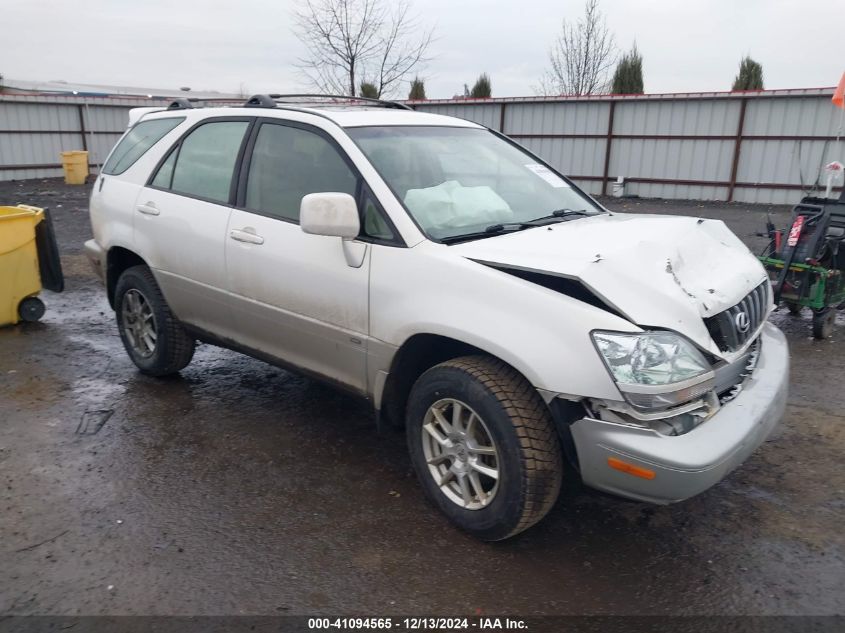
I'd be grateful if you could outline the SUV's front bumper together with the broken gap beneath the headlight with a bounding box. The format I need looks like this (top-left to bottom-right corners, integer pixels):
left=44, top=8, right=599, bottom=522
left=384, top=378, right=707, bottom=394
left=564, top=323, right=789, bottom=504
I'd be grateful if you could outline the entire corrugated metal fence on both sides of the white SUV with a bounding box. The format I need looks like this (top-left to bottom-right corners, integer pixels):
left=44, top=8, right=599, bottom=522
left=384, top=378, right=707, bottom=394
left=0, top=88, right=845, bottom=203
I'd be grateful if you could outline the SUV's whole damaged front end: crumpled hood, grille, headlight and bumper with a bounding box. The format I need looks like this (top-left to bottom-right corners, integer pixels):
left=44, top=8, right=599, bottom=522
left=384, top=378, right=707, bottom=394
left=452, top=214, right=789, bottom=503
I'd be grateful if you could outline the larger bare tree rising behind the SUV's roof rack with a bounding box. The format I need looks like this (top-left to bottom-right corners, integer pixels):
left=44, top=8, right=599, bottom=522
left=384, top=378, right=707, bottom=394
left=294, top=0, right=433, bottom=97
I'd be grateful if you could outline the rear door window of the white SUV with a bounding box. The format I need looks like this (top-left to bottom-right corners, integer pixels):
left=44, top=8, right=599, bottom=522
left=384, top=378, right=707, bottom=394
left=166, top=121, right=249, bottom=202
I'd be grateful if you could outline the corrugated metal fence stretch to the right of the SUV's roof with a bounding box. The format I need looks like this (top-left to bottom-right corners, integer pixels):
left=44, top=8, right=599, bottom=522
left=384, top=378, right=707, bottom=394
left=412, top=88, right=845, bottom=203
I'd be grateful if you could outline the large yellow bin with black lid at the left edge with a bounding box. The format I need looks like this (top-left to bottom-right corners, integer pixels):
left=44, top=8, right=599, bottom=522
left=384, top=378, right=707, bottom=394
left=0, top=204, right=64, bottom=326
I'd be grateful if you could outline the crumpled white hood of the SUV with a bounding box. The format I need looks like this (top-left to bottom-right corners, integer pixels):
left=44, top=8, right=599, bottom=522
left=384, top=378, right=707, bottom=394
left=450, top=213, right=767, bottom=356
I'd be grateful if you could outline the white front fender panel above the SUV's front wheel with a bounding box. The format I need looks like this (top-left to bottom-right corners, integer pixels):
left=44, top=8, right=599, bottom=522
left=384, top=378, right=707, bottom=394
left=370, top=243, right=639, bottom=400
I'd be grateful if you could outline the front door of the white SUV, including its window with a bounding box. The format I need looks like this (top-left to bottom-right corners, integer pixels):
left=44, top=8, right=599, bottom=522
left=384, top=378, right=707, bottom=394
left=226, top=119, right=371, bottom=392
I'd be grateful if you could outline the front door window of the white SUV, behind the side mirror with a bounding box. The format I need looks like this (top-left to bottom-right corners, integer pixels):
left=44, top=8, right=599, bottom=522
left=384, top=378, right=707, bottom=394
left=244, top=123, right=358, bottom=222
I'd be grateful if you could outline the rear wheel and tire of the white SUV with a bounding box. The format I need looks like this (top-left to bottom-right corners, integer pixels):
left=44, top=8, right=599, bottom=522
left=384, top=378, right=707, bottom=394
left=114, top=266, right=196, bottom=376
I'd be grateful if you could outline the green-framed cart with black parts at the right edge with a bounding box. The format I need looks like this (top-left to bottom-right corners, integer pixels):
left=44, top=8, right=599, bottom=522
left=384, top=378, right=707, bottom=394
left=760, top=191, right=845, bottom=339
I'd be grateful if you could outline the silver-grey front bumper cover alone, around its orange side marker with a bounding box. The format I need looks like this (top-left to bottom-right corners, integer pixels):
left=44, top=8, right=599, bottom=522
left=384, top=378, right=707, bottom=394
left=571, top=323, right=789, bottom=504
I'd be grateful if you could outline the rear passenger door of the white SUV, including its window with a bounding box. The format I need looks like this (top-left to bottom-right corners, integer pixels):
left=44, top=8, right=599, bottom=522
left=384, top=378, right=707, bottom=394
left=135, top=117, right=253, bottom=336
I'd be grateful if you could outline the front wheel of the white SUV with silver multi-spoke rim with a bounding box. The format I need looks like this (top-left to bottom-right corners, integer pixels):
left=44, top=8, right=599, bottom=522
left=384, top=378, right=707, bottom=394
left=406, top=356, right=563, bottom=541
